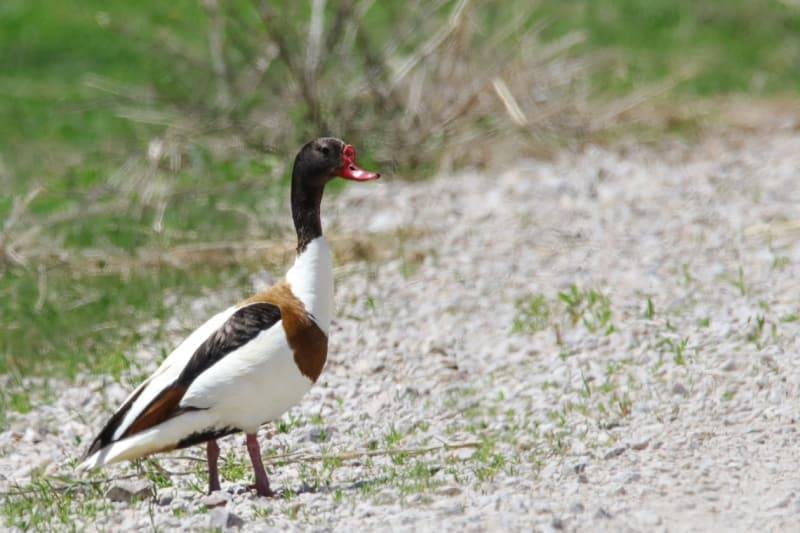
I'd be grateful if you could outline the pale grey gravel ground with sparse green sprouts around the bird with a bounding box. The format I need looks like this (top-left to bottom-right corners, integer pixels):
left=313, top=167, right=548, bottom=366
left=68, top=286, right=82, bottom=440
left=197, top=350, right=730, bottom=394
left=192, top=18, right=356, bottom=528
left=0, top=131, right=800, bottom=531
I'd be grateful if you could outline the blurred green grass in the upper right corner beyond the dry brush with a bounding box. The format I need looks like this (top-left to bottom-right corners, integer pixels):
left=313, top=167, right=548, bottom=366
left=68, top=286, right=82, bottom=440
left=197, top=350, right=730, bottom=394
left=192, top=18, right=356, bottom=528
left=541, top=0, right=800, bottom=96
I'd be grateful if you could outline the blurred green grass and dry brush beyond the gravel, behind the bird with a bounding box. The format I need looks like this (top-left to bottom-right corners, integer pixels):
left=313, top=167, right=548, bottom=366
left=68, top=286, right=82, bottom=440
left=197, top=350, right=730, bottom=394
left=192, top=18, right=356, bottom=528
left=0, top=0, right=800, bottom=412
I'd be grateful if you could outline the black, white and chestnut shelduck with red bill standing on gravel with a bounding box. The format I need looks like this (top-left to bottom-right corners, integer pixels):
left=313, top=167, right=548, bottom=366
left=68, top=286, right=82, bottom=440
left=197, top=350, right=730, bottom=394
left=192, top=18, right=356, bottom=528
left=78, top=137, right=380, bottom=497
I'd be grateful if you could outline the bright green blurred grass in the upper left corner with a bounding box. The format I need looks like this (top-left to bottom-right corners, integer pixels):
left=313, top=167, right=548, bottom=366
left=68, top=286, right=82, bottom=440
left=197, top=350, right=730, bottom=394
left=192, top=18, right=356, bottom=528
left=0, top=0, right=209, bottom=185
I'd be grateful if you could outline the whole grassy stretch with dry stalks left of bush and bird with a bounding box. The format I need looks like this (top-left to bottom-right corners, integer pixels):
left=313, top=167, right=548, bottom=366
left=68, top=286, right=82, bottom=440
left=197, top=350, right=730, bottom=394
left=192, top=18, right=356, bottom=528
left=0, top=0, right=296, bottom=394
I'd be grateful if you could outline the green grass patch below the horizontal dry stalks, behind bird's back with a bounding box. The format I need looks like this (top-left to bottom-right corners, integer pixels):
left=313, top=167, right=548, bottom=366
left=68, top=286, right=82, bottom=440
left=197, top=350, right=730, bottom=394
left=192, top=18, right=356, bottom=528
left=0, top=267, right=247, bottom=375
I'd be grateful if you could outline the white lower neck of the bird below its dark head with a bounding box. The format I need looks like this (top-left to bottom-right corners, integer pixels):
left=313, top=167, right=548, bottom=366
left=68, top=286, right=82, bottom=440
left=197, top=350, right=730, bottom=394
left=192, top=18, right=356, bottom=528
left=286, top=235, right=333, bottom=335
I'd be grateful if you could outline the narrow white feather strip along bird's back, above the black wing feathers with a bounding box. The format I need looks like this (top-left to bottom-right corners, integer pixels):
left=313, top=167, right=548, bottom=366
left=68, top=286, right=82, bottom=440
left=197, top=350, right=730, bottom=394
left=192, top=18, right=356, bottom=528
left=113, top=307, right=236, bottom=440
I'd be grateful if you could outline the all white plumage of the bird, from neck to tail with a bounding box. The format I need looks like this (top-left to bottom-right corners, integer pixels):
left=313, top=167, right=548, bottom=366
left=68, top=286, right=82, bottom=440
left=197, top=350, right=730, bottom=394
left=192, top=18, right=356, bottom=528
left=80, top=236, right=333, bottom=469
